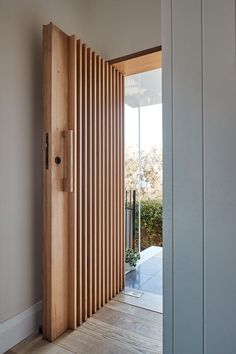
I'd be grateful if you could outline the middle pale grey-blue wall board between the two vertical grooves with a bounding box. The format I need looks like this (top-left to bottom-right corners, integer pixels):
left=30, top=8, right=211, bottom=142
left=172, top=0, right=203, bottom=354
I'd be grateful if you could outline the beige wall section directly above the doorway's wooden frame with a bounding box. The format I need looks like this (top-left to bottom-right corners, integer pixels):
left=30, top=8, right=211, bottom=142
left=89, top=0, right=161, bottom=59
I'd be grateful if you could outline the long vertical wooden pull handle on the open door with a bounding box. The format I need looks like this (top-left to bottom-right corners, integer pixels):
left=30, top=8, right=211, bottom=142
left=62, top=130, right=74, bottom=192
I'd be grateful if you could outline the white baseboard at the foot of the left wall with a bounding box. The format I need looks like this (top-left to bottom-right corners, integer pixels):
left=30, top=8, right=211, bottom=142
left=0, top=301, right=42, bottom=354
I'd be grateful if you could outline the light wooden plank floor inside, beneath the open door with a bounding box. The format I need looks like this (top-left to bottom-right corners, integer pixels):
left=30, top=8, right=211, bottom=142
left=7, top=300, right=162, bottom=354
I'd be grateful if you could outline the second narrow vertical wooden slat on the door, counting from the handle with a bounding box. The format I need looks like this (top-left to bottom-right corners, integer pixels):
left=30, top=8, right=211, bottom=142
left=81, top=44, right=88, bottom=321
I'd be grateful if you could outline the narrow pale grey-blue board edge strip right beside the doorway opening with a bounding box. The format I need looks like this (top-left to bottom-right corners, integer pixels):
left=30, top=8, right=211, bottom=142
left=162, top=0, right=173, bottom=354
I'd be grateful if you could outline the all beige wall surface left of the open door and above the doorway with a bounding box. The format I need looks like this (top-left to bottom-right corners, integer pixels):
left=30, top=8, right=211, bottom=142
left=0, top=0, right=161, bottom=322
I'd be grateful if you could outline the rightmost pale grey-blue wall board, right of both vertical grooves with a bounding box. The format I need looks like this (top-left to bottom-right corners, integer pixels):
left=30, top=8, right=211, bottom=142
left=203, top=0, right=236, bottom=354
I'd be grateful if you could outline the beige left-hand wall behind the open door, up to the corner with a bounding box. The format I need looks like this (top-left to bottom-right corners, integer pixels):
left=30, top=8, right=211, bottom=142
left=0, top=0, right=88, bottom=322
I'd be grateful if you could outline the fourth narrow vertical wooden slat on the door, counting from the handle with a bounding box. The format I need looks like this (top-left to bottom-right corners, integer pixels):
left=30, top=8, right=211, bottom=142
left=92, top=52, right=97, bottom=313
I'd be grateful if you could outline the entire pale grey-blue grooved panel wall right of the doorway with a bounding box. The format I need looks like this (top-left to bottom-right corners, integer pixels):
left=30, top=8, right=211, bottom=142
left=162, top=0, right=236, bottom=354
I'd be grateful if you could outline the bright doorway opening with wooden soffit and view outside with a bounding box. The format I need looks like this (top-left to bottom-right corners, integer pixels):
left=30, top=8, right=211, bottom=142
left=110, top=48, right=163, bottom=313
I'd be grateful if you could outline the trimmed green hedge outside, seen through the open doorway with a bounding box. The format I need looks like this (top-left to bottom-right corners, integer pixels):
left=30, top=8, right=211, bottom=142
left=135, top=199, right=162, bottom=250
